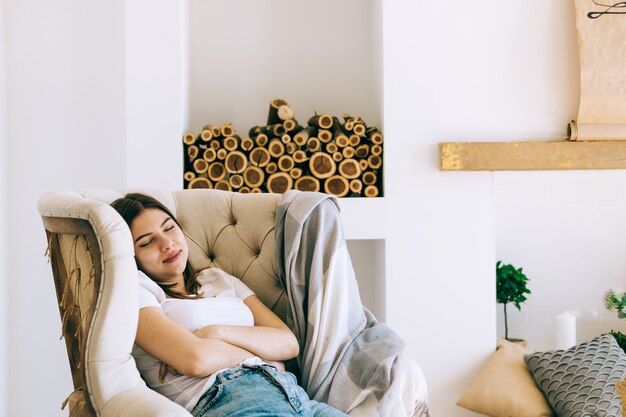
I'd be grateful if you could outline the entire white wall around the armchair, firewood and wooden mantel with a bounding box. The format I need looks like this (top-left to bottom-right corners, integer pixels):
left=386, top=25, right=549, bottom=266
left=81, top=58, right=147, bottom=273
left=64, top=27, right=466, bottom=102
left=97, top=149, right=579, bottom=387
left=0, top=0, right=626, bottom=417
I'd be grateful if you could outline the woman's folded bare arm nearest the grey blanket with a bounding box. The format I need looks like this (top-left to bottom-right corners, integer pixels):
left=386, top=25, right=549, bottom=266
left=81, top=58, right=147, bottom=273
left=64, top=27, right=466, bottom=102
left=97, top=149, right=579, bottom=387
left=194, top=295, right=300, bottom=361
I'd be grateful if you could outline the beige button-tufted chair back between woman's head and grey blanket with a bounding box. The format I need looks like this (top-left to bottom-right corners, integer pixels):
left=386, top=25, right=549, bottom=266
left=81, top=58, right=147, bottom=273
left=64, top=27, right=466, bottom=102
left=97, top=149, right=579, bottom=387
left=174, top=189, right=288, bottom=320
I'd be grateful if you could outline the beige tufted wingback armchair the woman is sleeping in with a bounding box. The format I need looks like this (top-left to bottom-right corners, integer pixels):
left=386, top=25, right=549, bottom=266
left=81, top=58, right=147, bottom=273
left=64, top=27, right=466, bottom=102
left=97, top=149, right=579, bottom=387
left=38, top=189, right=288, bottom=417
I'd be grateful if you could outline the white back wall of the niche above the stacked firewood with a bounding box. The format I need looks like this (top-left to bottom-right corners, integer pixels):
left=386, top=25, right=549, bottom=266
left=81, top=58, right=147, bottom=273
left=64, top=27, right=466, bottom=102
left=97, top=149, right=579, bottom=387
left=188, top=0, right=382, bottom=137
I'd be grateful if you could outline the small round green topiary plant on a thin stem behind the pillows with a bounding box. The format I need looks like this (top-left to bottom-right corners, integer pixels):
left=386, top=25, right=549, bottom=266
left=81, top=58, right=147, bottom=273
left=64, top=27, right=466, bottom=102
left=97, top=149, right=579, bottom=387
left=496, top=261, right=530, bottom=341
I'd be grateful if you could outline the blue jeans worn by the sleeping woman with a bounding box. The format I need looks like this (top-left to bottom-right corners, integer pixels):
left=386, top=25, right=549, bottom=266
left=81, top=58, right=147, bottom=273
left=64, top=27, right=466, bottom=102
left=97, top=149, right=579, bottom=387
left=191, top=365, right=347, bottom=417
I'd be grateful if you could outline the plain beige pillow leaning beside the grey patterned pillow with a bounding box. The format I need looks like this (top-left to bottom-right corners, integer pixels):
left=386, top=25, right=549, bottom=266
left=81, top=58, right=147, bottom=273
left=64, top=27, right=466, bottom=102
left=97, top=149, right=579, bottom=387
left=457, top=339, right=554, bottom=417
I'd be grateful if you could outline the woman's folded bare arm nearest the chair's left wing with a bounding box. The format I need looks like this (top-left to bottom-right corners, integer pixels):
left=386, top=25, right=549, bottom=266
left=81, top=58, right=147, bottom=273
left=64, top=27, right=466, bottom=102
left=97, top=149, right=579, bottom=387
left=135, top=307, right=255, bottom=377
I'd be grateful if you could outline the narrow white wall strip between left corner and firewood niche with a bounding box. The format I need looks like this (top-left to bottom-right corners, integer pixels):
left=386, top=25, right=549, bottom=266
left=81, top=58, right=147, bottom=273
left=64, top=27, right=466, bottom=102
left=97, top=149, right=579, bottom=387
left=123, top=0, right=187, bottom=190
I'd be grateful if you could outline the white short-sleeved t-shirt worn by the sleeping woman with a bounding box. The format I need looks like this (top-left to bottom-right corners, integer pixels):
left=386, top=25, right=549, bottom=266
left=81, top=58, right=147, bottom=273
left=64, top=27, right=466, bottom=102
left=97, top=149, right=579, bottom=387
left=132, top=268, right=257, bottom=411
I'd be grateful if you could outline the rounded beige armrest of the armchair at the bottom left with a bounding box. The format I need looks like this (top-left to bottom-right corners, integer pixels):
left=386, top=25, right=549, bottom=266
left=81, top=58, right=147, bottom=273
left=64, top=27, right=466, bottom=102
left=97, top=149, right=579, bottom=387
left=100, top=387, right=191, bottom=417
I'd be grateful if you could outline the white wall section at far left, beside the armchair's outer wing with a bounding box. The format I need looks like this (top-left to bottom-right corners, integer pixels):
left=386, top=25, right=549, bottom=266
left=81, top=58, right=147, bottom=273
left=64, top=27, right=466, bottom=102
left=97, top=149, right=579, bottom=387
left=2, top=0, right=126, bottom=417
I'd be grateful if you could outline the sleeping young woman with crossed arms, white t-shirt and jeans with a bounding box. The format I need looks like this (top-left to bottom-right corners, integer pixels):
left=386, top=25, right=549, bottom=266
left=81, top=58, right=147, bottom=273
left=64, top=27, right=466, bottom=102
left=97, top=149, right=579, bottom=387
left=112, top=193, right=346, bottom=417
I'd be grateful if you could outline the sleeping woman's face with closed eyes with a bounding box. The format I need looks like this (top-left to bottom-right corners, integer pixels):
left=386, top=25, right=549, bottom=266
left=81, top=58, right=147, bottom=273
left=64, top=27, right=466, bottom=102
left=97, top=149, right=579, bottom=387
left=130, top=208, right=189, bottom=284
